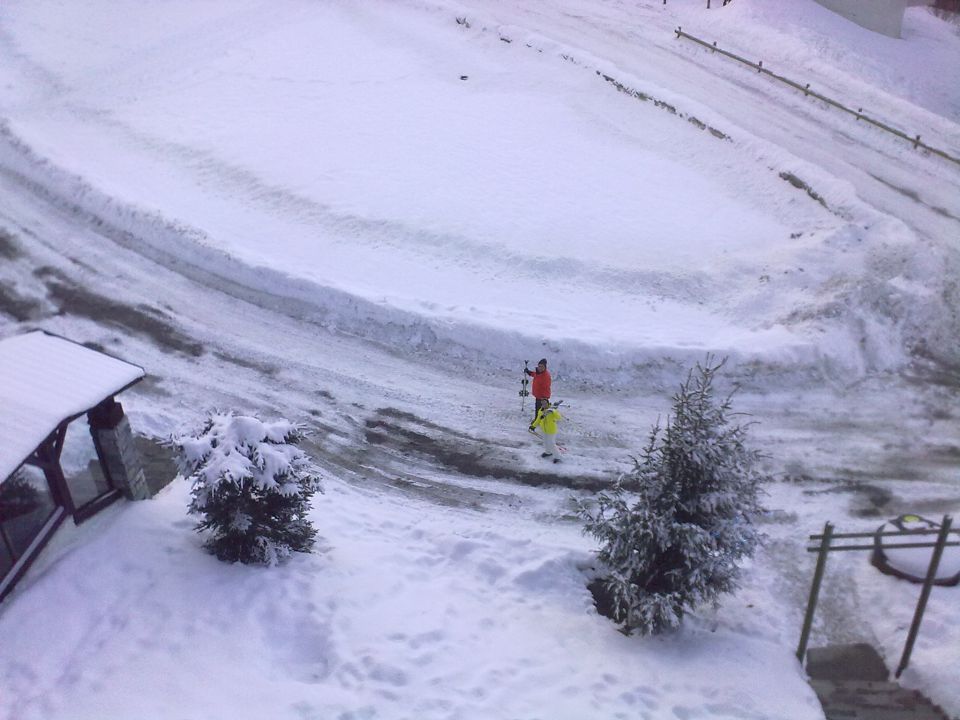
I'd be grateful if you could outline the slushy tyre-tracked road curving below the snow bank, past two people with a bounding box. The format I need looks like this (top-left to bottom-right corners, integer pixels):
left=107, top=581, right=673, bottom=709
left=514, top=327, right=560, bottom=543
left=0, top=153, right=957, bottom=496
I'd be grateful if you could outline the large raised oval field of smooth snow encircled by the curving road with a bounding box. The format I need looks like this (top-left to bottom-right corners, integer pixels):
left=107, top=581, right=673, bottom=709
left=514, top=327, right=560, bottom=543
left=0, top=3, right=957, bottom=385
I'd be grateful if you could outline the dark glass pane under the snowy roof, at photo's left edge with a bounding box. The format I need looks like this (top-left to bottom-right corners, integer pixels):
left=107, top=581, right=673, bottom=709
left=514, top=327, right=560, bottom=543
left=0, top=465, right=54, bottom=565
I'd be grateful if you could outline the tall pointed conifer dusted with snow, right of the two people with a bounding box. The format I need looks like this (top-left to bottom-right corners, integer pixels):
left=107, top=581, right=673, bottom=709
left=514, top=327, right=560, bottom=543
left=581, top=357, right=764, bottom=634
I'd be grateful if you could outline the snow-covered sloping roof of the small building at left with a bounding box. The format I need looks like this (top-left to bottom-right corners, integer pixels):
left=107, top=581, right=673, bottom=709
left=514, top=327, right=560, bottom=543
left=0, top=331, right=144, bottom=482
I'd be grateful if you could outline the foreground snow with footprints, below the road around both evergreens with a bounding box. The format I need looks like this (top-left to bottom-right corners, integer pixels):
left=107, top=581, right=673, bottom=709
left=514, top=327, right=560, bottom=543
left=0, top=472, right=820, bottom=719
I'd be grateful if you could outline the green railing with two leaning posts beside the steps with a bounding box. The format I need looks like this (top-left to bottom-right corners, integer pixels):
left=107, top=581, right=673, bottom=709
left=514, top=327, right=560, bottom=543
left=797, top=515, right=960, bottom=677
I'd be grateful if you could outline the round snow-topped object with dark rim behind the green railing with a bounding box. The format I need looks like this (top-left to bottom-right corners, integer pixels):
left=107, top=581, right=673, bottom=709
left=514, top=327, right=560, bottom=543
left=870, top=515, right=960, bottom=586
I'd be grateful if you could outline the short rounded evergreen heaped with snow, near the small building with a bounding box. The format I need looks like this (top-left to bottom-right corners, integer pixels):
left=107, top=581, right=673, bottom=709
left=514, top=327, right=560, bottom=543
left=170, top=412, right=322, bottom=565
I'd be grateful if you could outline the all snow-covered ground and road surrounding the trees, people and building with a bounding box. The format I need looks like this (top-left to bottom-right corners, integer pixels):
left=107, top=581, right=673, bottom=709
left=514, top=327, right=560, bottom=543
left=0, top=0, right=960, bottom=720
